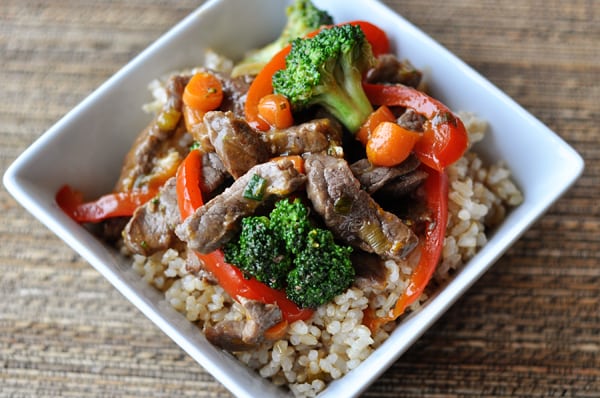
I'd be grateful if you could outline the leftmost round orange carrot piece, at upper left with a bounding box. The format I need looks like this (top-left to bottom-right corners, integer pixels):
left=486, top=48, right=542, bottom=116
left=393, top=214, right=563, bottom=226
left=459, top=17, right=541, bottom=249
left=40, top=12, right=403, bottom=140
left=182, top=72, right=223, bottom=112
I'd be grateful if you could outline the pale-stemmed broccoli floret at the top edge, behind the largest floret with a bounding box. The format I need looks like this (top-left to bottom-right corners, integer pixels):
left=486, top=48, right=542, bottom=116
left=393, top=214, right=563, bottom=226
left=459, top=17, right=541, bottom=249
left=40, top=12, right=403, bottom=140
left=232, top=0, right=333, bottom=76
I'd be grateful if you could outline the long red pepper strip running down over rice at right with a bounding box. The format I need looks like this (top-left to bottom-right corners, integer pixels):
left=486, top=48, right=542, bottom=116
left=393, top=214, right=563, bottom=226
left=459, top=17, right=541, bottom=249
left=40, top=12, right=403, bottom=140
left=363, top=167, right=448, bottom=332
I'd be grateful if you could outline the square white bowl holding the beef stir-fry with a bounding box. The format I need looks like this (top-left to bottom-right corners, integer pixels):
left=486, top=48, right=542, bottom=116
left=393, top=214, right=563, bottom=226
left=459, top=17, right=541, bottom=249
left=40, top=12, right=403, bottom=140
left=4, top=0, right=583, bottom=397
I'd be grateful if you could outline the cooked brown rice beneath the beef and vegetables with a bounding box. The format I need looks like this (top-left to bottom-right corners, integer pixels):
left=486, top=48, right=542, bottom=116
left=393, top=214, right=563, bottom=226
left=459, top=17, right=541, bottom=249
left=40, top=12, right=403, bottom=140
left=133, top=108, right=523, bottom=397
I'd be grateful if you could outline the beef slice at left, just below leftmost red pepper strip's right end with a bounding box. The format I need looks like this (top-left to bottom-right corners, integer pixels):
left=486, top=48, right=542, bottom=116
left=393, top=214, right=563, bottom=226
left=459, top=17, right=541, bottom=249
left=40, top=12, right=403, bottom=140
left=123, top=177, right=180, bottom=256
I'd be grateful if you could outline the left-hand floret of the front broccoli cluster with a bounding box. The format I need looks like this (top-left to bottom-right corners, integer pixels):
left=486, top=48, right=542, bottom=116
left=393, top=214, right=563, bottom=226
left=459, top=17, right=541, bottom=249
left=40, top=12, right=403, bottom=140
left=224, top=216, right=292, bottom=289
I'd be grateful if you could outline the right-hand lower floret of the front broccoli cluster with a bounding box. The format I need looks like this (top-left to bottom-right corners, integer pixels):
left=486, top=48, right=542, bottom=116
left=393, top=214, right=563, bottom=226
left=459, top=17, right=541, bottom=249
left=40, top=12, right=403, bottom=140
left=286, top=228, right=355, bottom=308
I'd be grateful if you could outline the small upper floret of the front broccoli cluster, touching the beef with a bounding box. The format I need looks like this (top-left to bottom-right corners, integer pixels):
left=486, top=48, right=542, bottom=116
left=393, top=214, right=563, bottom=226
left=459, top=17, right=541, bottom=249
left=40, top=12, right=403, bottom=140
left=270, top=198, right=311, bottom=254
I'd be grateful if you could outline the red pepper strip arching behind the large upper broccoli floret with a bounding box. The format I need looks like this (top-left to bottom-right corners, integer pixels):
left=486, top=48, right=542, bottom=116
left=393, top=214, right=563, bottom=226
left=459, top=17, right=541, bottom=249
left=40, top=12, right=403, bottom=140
left=244, top=21, right=390, bottom=131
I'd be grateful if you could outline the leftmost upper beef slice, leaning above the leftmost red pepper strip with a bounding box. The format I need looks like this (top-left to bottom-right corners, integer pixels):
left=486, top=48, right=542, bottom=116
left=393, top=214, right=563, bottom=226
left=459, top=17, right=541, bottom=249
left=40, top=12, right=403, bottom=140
left=115, top=76, right=191, bottom=192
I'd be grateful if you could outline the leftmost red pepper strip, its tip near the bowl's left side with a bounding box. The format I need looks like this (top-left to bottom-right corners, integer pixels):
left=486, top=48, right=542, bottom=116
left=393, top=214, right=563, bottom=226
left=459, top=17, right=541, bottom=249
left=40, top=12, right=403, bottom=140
left=55, top=185, right=158, bottom=223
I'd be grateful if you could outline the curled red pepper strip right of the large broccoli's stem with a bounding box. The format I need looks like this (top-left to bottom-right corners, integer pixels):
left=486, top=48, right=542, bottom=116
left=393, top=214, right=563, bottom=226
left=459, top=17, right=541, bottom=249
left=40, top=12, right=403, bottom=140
left=363, top=83, right=469, bottom=171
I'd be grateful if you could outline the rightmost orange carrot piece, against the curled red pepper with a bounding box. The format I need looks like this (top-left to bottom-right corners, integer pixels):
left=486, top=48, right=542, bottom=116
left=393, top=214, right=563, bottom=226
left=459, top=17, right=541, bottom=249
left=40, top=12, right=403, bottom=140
left=367, top=122, right=421, bottom=167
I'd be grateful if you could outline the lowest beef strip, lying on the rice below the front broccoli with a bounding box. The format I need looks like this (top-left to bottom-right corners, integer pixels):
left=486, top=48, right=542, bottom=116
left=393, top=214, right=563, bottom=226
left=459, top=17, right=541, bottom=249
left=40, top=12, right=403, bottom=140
left=204, top=297, right=283, bottom=352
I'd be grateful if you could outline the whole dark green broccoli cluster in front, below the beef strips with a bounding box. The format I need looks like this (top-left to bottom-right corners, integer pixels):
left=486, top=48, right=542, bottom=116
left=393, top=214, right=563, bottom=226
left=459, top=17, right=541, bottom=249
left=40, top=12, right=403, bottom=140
left=224, top=199, right=354, bottom=308
